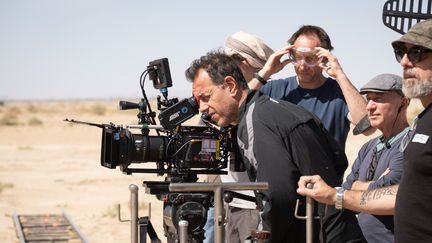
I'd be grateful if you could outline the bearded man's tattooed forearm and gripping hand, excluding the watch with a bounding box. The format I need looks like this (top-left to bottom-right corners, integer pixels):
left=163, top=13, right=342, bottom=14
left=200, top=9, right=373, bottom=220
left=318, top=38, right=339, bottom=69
left=297, top=175, right=399, bottom=215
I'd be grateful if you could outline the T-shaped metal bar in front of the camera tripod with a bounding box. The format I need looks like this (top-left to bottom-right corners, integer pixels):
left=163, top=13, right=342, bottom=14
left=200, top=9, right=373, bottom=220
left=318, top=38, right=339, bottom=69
left=169, top=182, right=268, bottom=243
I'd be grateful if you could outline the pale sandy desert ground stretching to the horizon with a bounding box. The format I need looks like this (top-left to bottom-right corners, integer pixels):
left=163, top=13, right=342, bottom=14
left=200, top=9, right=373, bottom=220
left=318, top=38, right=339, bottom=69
left=0, top=100, right=419, bottom=243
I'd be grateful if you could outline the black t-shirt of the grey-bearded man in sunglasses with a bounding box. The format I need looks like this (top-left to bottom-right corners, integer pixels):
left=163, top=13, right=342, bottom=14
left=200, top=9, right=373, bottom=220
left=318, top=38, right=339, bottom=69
left=395, top=105, right=432, bottom=243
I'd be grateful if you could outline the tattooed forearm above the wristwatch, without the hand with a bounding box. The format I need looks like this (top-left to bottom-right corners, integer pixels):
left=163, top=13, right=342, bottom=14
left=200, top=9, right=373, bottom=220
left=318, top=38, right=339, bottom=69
left=343, top=185, right=399, bottom=215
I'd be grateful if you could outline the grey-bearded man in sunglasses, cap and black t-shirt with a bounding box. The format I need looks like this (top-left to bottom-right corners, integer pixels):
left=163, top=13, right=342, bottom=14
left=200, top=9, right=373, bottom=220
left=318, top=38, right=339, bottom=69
left=297, top=19, right=432, bottom=242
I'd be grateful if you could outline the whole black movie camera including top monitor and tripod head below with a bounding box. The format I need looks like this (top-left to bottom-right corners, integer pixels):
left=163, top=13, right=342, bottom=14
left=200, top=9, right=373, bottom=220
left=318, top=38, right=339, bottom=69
left=66, top=58, right=241, bottom=242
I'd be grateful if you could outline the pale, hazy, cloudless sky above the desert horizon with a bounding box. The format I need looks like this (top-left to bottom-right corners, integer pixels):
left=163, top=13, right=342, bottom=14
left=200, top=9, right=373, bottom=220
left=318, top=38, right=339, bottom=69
left=0, top=0, right=401, bottom=100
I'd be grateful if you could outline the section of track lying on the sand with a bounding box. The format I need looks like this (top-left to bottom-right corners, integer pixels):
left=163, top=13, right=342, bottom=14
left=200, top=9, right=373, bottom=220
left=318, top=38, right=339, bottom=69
left=12, top=210, right=88, bottom=243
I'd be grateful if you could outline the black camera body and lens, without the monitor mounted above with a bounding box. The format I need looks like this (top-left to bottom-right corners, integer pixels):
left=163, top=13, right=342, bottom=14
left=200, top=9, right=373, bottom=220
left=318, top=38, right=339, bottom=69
left=101, top=125, right=228, bottom=175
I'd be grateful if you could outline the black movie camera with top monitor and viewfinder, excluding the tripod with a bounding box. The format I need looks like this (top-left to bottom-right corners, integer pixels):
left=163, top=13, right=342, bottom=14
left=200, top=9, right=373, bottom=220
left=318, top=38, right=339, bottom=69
left=94, top=58, right=235, bottom=178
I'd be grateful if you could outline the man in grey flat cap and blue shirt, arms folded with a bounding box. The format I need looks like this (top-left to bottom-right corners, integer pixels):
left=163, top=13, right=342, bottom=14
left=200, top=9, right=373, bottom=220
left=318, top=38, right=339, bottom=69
left=338, top=74, right=409, bottom=243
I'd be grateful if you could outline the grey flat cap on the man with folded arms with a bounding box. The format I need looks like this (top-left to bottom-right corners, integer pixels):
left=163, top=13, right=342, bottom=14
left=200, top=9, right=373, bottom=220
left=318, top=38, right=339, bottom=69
left=360, top=73, right=403, bottom=95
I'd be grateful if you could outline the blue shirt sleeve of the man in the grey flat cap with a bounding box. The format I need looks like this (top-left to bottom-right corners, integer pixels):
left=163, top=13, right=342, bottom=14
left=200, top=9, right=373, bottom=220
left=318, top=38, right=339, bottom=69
left=368, top=146, right=404, bottom=190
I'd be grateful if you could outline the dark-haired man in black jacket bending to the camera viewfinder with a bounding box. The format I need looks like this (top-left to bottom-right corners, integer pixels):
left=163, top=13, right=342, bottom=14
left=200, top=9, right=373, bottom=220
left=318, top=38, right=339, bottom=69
left=186, top=53, right=363, bottom=242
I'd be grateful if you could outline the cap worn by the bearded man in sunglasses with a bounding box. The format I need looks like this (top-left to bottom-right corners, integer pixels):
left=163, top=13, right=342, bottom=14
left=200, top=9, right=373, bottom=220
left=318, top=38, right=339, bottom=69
left=392, top=19, right=432, bottom=50
